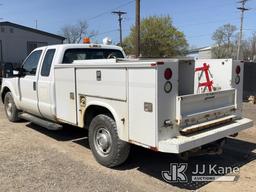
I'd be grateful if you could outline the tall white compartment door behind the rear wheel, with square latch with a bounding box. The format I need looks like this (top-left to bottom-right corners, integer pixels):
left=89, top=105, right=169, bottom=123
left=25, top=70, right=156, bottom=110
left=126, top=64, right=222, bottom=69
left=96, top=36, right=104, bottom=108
left=129, top=69, right=157, bottom=147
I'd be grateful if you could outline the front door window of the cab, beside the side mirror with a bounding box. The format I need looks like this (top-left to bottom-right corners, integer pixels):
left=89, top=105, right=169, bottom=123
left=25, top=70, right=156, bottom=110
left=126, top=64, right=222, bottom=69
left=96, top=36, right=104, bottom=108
left=22, top=50, right=42, bottom=76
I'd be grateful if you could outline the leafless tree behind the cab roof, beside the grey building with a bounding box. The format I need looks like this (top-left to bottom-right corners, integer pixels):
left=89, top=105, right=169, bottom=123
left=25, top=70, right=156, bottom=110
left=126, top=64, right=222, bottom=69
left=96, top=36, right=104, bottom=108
left=61, top=21, right=96, bottom=43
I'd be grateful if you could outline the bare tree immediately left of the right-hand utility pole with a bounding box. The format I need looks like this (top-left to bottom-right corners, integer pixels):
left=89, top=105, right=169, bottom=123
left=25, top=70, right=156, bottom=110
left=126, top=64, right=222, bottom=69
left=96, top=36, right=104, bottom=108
left=212, top=24, right=237, bottom=58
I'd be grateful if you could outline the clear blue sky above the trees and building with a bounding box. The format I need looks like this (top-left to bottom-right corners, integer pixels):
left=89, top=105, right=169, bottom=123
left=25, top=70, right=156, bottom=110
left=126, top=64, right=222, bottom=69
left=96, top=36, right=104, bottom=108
left=0, top=0, right=256, bottom=47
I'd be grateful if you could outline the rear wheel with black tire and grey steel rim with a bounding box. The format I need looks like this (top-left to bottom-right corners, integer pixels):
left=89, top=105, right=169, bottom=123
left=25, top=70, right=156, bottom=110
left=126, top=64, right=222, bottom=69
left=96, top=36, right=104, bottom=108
left=89, top=114, right=130, bottom=167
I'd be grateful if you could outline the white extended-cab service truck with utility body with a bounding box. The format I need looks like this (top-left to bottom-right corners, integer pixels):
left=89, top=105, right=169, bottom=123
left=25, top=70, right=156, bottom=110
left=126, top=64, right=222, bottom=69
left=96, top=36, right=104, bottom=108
left=1, top=44, right=252, bottom=167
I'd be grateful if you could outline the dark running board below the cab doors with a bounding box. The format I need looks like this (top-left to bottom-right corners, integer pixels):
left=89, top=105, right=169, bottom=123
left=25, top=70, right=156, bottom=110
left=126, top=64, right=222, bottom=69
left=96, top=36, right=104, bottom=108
left=19, top=113, right=63, bottom=131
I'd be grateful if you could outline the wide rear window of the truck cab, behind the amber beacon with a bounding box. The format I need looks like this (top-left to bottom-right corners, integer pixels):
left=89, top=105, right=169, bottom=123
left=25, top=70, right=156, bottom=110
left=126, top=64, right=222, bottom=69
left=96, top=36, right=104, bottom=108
left=62, top=48, right=124, bottom=64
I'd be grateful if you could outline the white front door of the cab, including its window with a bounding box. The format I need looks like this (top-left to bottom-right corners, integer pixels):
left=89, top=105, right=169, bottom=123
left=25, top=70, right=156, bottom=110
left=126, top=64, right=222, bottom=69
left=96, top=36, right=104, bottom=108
left=19, top=49, right=43, bottom=116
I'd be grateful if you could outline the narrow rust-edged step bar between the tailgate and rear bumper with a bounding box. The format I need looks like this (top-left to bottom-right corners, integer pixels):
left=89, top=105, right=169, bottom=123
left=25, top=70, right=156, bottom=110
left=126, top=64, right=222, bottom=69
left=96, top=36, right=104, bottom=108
left=180, top=115, right=235, bottom=135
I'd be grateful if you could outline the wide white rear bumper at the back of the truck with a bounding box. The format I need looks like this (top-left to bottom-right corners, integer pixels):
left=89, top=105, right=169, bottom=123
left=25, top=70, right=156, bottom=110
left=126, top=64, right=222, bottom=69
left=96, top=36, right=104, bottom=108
left=158, top=118, right=253, bottom=154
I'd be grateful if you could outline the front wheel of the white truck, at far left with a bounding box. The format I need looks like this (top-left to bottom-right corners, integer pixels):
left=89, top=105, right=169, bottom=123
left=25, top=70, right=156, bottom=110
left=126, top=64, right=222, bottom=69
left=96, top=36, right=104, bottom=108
left=4, top=92, right=20, bottom=122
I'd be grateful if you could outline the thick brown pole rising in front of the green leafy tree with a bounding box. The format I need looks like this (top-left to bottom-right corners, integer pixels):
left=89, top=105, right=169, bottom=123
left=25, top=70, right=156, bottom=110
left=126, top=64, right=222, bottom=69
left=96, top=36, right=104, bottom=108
left=135, top=0, right=140, bottom=58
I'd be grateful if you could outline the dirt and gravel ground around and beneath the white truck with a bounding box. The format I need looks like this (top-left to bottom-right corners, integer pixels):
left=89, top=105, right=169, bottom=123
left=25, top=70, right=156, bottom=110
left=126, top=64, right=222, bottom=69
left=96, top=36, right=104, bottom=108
left=0, top=103, right=256, bottom=192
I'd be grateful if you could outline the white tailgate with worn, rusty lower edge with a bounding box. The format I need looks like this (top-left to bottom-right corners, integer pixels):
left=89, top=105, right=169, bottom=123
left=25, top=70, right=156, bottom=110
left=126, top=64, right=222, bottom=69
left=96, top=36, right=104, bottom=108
left=176, top=89, right=236, bottom=128
